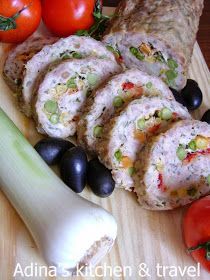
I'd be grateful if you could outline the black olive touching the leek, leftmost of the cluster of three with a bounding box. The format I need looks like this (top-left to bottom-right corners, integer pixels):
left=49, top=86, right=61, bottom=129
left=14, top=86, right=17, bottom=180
left=34, top=138, right=74, bottom=165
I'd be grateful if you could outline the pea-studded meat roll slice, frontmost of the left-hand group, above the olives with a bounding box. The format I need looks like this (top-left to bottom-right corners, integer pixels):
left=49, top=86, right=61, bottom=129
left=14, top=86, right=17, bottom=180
left=35, top=58, right=121, bottom=138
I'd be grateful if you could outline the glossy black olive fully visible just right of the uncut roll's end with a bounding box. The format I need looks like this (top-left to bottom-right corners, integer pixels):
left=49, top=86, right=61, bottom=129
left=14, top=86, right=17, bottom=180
left=181, top=79, right=203, bottom=111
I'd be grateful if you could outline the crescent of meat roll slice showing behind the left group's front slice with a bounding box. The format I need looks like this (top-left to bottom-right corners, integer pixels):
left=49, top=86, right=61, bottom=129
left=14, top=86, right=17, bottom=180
left=22, top=36, right=119, bottom=116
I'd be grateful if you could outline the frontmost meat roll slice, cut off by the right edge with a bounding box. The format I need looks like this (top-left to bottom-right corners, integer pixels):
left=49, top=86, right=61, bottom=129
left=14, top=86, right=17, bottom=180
left=133, top=120, right=210, bottom=210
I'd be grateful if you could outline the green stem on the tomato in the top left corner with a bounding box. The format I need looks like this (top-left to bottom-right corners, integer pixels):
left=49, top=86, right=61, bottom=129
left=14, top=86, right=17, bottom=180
left=0, top=2, right=32, bottom=31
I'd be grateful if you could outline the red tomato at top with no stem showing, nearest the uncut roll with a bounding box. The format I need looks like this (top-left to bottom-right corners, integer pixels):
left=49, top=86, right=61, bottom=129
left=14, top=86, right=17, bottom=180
left=42, top=0, right=95, bottom=37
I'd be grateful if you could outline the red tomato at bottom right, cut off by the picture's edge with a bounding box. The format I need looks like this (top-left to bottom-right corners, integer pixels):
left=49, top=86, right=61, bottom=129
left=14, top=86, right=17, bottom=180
left=183, top=196, right=210, bottom=272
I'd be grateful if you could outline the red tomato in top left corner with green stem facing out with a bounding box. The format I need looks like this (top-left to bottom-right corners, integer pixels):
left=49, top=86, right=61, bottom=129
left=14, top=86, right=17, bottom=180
left=0, top=0, right=41, bottom=43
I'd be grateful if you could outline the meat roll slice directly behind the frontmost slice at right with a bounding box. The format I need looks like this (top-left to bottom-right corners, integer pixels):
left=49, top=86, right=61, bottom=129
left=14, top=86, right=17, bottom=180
left=98, top=97, right=191, bottom=190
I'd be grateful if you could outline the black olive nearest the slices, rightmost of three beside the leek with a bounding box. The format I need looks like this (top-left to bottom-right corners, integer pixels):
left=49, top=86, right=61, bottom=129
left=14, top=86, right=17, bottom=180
left=87, top=158, right=115, bottom=197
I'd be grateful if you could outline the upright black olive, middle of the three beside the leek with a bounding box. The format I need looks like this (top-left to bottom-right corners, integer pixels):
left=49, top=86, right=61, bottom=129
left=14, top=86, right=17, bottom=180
left=60, top=147, right=88, bottom=193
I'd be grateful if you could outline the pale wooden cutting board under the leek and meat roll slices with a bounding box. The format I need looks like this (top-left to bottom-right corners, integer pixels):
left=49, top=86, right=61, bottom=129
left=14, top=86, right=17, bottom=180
left=0, top=9, right=210, bottom=280
